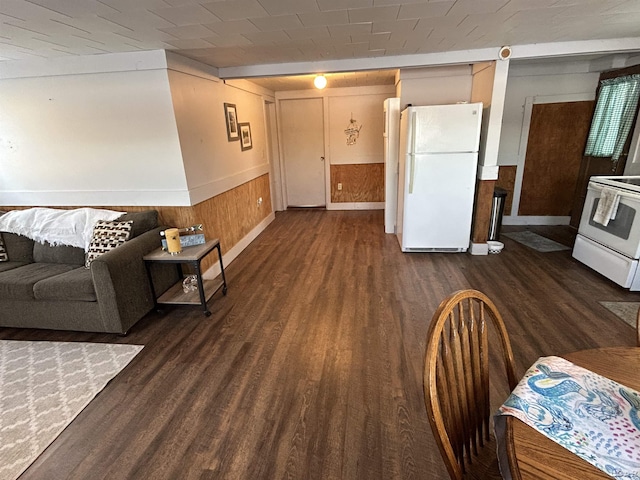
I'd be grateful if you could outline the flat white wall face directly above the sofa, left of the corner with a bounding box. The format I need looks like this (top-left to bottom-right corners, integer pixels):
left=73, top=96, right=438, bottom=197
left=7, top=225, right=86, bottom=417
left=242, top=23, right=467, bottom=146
left=0, top=65, right=189, bottom=206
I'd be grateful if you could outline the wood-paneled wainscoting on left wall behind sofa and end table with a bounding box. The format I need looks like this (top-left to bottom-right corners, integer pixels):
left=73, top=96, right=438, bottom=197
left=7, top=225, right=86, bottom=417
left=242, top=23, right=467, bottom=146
left=0, top=174, right=272, bottom=271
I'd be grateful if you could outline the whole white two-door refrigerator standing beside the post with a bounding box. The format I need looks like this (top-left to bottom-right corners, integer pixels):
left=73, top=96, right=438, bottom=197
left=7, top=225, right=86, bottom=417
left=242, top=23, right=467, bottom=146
left=396, top=103, right=482, bottom=252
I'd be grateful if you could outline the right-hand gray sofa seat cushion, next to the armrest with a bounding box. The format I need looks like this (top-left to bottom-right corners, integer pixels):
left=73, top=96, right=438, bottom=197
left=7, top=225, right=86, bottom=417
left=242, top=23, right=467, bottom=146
left=33, top=267, right=97, bottom=302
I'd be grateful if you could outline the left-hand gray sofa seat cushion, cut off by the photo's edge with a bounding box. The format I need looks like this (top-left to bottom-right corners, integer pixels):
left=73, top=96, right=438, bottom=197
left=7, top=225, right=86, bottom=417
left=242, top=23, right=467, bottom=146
left=0, top=263, right=78, bottom=300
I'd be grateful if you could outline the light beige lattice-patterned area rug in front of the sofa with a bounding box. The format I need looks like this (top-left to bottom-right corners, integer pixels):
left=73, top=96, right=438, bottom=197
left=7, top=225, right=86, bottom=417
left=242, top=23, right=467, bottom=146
left=0, top=340, right=143, bottom=480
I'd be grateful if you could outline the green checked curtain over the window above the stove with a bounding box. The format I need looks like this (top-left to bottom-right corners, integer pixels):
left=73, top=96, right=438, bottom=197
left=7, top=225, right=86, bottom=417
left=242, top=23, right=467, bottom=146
left=584, top=74, right=640, bottom=161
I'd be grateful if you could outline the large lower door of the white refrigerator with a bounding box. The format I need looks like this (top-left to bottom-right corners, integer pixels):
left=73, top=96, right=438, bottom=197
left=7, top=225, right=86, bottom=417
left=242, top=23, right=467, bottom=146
left=401, top=153, right=478, bottom=252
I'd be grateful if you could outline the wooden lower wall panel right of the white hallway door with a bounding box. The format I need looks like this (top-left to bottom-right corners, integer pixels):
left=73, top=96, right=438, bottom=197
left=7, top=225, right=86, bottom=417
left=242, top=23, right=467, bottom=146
left=331, top=163, right=384, bottom=203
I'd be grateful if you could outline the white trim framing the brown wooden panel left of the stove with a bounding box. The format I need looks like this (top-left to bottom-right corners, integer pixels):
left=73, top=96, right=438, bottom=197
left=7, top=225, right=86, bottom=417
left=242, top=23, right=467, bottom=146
left=508, top=92, right=596, bottom=225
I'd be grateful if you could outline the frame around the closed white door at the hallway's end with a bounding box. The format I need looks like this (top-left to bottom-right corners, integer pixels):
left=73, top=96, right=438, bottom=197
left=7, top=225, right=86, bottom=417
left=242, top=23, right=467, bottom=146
left=276, top=92, right=331, bottom=210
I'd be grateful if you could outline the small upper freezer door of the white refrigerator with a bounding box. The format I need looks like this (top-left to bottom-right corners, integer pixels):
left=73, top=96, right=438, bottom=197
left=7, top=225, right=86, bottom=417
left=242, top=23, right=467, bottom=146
left=408, top=103, right=482, bottom=154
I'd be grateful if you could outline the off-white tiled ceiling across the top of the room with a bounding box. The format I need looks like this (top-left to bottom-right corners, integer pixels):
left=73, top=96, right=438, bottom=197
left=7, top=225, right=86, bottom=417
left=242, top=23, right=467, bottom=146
left=0, top=0, right=640, bottom=89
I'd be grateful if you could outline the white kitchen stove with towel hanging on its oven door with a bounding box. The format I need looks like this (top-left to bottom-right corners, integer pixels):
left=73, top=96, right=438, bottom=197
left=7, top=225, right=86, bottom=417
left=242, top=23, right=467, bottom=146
left=573, top=176, right=640, bottom=291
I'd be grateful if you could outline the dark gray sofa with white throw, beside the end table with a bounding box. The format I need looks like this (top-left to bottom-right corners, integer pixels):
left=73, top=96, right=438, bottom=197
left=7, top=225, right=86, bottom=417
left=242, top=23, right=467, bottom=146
left=0, top=210, right=178, bottom=334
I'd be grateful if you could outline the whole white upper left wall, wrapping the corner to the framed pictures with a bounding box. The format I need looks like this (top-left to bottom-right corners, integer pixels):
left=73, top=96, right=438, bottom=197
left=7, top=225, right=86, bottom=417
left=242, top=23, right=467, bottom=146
left=0, top=51, right=269, bottom=206
